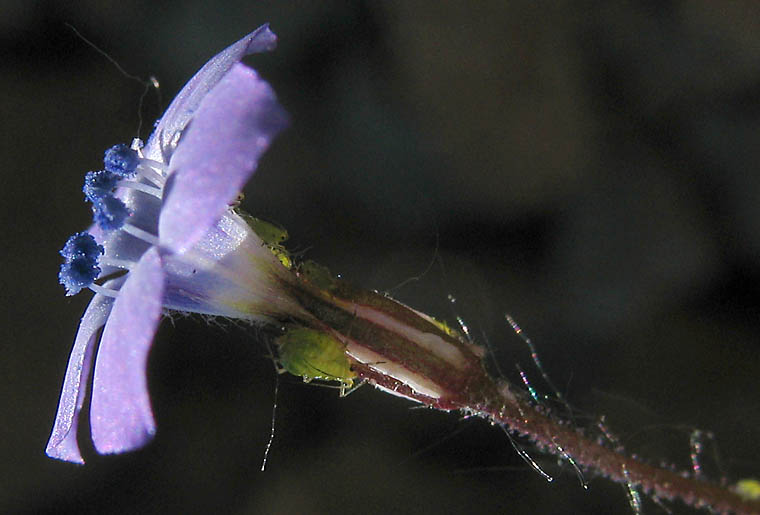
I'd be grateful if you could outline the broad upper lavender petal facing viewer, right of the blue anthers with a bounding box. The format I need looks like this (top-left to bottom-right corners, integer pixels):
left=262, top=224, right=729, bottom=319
left=158, top=64, right=287, bottom=253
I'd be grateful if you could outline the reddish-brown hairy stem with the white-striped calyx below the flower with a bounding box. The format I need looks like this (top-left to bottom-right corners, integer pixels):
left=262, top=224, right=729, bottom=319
left=283, top=272, right=760, bottom=513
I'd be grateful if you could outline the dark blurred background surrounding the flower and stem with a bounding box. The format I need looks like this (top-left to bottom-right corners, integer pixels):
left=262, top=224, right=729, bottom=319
left=0, top=0, right=760, bottom=514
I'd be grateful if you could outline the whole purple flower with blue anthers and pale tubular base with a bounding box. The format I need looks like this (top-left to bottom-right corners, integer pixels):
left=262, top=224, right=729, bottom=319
left=46, top=25, right=298, bottom=463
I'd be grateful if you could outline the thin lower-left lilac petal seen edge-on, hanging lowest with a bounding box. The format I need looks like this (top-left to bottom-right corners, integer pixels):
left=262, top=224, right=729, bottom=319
left=45, top=279, right=123, bottom=463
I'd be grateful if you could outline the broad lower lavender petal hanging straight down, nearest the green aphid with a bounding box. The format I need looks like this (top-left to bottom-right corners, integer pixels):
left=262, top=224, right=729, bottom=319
left=90, top=248, right=164, bottom=454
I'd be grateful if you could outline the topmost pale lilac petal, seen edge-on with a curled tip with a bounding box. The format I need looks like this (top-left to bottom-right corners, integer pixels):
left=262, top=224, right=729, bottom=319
left=144, top=23, right=277, bottom=161
